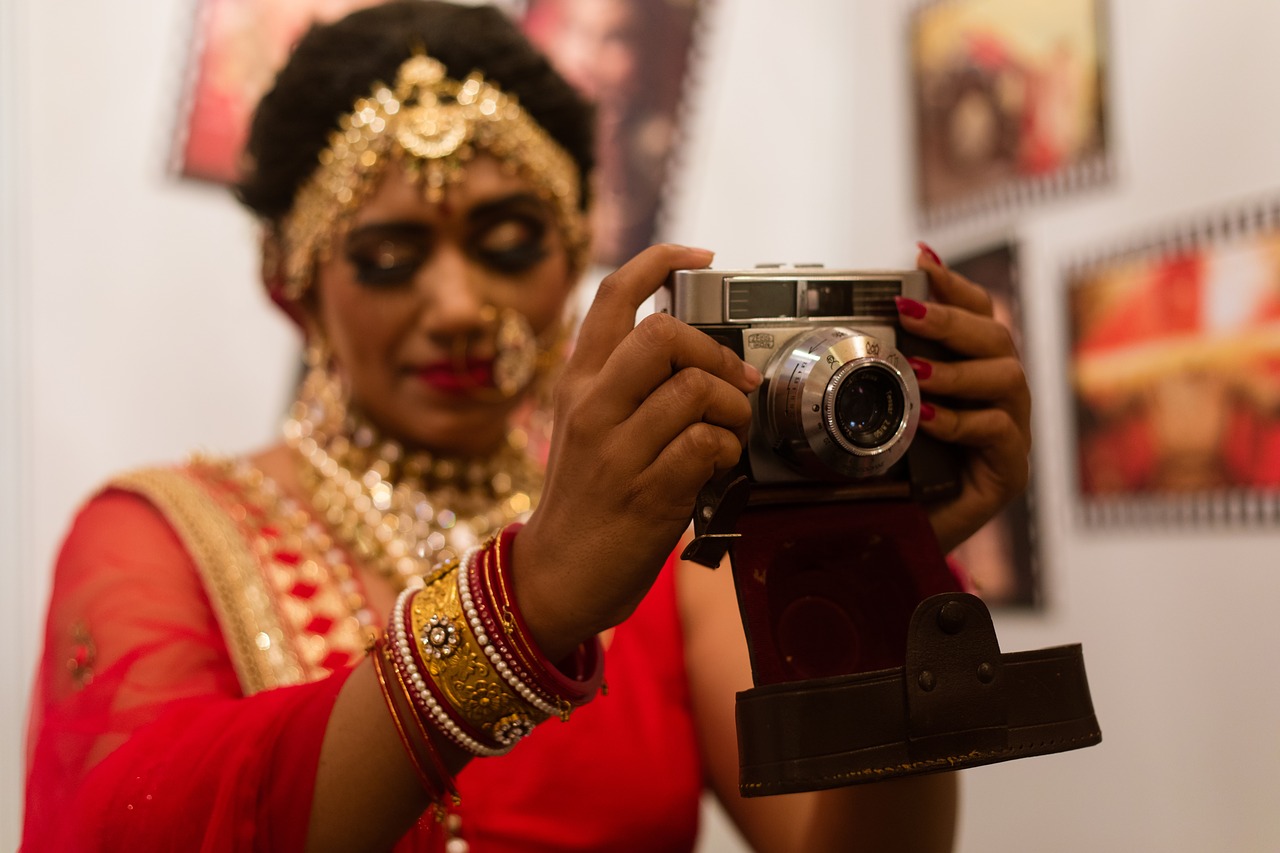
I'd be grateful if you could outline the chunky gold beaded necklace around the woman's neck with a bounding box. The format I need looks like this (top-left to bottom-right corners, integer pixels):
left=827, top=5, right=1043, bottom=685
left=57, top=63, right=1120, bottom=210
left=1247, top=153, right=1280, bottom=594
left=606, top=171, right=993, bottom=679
left=284, top=343, right=543, bottom=588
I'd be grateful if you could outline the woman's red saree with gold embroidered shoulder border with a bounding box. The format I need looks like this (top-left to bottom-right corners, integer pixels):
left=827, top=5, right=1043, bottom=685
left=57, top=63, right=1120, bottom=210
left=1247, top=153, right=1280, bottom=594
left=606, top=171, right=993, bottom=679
left=23, top=462, right=701, bottom=853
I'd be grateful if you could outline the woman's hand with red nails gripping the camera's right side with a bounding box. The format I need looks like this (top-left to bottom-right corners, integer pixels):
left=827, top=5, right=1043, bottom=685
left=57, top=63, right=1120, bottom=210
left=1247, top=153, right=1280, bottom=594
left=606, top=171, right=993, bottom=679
left=899, top=245, right=1032, bottom=552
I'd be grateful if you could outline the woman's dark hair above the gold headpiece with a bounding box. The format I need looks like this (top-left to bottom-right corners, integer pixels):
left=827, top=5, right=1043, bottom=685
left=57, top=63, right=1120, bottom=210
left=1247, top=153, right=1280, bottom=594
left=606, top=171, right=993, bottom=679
left=234, top=0, right=595, bottom=222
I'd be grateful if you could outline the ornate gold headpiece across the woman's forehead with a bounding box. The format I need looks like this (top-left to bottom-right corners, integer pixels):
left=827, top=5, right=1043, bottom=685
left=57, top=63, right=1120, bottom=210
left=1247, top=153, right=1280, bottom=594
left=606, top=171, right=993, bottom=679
left=282, top=54, right=589, bottom=300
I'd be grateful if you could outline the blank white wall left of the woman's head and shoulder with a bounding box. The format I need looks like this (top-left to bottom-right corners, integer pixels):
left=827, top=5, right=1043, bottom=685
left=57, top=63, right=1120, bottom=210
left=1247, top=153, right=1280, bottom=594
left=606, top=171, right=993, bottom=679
left=0, top=0, right=294, bottom=835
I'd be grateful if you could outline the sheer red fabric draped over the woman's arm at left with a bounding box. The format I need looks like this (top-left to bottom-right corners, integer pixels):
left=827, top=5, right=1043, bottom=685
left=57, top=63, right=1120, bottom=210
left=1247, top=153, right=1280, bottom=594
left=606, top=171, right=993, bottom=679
left=23, top=491, right=348, bottom=850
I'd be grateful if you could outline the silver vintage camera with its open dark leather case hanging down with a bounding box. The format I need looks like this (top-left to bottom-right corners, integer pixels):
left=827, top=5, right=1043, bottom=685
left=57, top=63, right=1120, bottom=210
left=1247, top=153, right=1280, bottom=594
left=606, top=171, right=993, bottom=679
left=657, top=265, right=1101, bottom=797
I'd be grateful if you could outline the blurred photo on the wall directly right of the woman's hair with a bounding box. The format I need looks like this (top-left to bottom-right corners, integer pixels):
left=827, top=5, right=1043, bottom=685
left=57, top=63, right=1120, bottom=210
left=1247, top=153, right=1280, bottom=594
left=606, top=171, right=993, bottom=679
left=524, top=0, right=700, bottom=266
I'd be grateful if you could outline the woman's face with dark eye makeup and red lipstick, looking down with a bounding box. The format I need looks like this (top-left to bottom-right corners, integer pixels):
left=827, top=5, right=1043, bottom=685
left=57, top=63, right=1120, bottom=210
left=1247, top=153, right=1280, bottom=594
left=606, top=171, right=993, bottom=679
left=307, top=155, right=572, bottom=456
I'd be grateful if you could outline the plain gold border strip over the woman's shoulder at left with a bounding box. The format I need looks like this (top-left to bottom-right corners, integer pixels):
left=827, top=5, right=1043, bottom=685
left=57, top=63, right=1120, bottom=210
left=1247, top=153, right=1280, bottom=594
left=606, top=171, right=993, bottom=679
left=111, top=469, right=305, bottom=695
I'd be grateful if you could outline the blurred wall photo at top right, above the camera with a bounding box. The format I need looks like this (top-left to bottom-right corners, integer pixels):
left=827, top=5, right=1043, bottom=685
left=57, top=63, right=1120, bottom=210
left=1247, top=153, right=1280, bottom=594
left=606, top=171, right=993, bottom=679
left=909, top=0, right=1111, bottom=225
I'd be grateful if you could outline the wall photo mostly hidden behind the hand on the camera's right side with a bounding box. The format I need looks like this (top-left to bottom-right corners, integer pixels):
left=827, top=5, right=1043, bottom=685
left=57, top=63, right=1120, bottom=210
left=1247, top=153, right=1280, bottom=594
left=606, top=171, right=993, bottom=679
left=947, top=241, right=1042, bottom=607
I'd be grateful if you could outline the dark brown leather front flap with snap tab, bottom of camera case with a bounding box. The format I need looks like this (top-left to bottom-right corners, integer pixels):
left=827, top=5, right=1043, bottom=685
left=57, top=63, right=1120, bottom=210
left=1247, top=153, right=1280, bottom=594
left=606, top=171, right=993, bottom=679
left=737, top=593, right=1102, bottom=797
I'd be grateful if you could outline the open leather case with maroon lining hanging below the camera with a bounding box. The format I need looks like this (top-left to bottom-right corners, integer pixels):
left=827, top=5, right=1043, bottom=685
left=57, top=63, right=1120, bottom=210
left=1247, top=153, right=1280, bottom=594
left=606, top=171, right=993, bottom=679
left=708, top=496, right=1102, bottom=797
